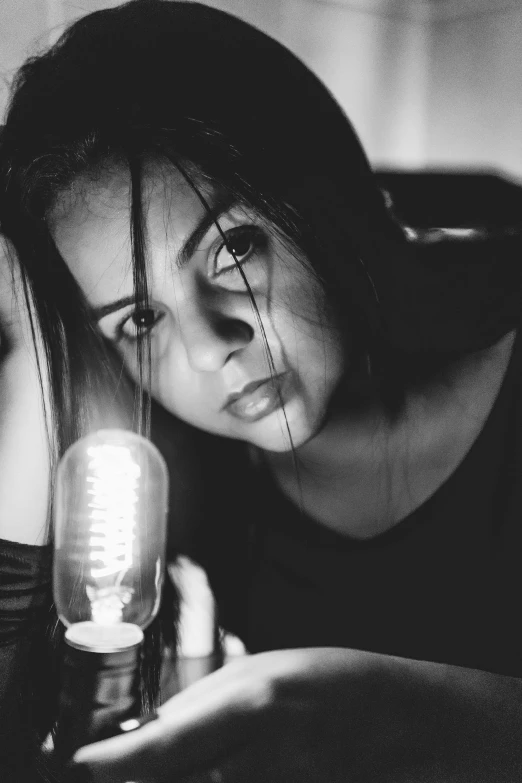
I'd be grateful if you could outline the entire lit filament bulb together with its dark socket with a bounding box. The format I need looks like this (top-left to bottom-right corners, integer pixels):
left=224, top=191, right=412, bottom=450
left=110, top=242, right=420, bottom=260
left=53, top=430, right=168, bottom=756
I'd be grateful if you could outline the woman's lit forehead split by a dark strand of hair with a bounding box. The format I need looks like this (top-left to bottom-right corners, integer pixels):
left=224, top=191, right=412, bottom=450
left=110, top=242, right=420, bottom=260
left=51, top=166, right=207, bottom=306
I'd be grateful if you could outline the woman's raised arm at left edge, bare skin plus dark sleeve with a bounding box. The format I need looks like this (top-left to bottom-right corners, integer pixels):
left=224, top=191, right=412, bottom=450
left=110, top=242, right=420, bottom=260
left=0, top=237, right=53, bottom=781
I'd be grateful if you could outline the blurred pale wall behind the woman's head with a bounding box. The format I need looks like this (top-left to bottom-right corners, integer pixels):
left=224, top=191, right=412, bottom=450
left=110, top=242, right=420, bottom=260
left=0, top=0, right=522, bottom=181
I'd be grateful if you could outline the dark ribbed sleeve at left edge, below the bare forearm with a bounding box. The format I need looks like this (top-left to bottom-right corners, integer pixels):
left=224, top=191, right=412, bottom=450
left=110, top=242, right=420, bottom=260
left=0, top=539, right=51, bottom=783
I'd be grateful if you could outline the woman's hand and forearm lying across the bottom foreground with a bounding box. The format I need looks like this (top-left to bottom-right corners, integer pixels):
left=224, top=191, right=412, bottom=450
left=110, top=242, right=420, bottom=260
left=71, top=648, right=522, bottom=783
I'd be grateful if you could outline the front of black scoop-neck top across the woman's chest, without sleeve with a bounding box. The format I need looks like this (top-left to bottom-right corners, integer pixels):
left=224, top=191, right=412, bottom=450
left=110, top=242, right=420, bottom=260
left=208, top=328, right=522, bottom=676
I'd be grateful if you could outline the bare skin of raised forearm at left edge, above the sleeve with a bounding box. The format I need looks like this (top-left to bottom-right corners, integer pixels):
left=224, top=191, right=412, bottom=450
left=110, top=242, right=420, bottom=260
left=0, top=237, right=50, bottom=544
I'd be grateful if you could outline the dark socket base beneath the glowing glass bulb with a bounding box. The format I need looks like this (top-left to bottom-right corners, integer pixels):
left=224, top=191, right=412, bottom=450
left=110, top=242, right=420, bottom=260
left=54, top=623, right=143, bottom=762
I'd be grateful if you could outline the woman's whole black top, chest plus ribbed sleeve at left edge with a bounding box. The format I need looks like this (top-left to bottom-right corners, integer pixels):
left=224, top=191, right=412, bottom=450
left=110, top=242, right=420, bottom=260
left=0, top=330, right=522, bottom=779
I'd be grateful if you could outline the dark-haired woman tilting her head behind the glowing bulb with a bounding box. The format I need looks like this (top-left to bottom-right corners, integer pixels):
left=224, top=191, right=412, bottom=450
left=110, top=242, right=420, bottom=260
left=1, top=0, right=522, bottom=783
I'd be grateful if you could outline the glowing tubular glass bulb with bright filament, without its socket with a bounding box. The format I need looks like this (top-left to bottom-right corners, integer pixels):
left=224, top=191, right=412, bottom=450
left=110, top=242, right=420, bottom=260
left=54, top=430, right=168, bottom=651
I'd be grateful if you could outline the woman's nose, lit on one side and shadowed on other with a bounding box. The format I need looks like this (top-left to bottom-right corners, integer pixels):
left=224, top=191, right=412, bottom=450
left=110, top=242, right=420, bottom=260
left=180, top=307, right=254, bottom=372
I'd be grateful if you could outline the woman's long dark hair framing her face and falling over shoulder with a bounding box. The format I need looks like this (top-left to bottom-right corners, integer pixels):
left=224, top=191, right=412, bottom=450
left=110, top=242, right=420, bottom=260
left=0, top=0, right=521, bottom=776
